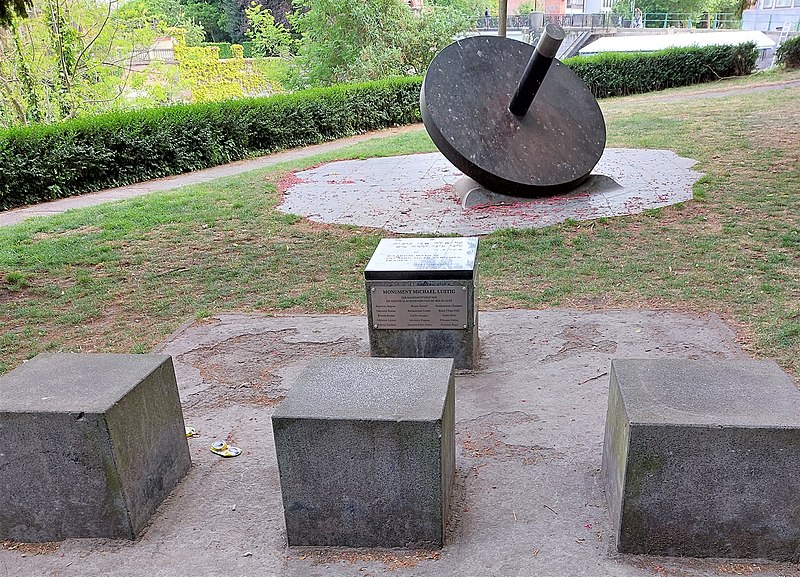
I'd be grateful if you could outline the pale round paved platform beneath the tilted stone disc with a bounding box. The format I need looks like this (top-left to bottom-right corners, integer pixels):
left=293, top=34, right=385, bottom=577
left=278, top=148, right=702, bottom=235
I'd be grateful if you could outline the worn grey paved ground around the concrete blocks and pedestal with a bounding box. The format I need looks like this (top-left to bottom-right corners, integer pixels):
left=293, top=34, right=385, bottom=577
left=0, top=310, right=800, bottom=577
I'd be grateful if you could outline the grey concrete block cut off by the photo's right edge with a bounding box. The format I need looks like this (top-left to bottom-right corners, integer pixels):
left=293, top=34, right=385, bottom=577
left=603, top=359, right=800, bottom=562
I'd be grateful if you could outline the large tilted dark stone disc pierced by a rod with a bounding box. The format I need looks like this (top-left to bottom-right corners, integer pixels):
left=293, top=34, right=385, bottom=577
left=420, top=36, right=606, bottom=196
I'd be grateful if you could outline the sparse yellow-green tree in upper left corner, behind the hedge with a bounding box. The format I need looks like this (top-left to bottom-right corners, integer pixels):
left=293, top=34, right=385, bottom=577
left=0, top=0, right=202, bottom=126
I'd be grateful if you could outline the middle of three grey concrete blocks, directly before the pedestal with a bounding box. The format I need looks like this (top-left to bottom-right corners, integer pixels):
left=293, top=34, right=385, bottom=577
left=272, top=358, right=455, bottom=547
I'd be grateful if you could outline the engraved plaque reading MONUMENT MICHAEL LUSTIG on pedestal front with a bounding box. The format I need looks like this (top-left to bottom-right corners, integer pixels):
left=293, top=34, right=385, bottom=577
left=371, top=285, right=469, bottom=329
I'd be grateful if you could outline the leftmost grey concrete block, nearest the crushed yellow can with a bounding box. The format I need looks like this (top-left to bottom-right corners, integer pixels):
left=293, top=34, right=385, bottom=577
left=0, top=354, right=191, bottom=542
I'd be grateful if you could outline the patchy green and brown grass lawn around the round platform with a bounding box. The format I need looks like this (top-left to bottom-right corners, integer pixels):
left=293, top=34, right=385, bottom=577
left=0, top=72, right=800, bottom=377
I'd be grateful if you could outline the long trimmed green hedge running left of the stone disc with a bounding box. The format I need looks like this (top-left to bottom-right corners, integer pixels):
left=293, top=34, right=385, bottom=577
left=0, top=78, right=421, bottom=210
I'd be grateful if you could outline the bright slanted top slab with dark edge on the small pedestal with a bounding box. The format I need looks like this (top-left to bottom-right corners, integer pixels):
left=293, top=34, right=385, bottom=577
left=364, top=238, right=478, bottom=280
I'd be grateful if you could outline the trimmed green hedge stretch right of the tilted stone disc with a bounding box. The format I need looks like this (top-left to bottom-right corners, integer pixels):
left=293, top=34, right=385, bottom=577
left=564, top=43, right=758, bottom=98
